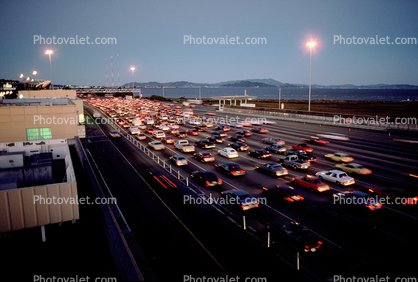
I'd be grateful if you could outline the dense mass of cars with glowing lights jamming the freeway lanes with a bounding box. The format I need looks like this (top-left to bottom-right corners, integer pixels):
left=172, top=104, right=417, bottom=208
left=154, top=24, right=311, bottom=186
left=84, top=98, right=418, bottom=278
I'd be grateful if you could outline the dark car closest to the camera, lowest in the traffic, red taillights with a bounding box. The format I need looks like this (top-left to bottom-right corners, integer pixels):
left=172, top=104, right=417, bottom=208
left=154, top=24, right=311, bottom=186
left=268, top=220, right=322, bottom=252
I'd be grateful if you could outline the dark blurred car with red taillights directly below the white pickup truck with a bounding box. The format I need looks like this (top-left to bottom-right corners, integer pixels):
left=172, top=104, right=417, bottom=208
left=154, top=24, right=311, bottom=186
left=333, top=191, right=382, bottom=211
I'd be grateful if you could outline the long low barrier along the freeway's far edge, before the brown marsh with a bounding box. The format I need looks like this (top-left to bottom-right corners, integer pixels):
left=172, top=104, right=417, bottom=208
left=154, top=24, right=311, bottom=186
left=221, top=107, right=418, bottom=131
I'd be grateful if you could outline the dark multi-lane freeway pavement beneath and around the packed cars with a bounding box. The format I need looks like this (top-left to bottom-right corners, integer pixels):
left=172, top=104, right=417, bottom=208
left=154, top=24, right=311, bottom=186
left=82, top=100, right=418, bottom=281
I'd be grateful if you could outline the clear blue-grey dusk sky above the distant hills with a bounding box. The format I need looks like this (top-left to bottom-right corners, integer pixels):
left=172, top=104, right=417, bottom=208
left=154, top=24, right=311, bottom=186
left=0, top=0, right=418, bottom=86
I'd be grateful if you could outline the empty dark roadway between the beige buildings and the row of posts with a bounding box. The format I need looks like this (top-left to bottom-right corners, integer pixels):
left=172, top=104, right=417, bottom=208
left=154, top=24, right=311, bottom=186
left=82, top=107, right=306, bottom=281
